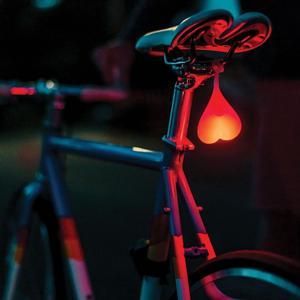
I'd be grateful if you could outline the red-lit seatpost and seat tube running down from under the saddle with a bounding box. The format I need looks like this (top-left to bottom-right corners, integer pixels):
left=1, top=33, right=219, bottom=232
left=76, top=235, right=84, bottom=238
left=163, top=74, right=212, bottom=300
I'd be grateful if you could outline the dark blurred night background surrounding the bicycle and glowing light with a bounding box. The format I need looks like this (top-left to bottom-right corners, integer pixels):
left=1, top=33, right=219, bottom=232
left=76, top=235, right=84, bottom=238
left=0, top=0, right=300, bottom=299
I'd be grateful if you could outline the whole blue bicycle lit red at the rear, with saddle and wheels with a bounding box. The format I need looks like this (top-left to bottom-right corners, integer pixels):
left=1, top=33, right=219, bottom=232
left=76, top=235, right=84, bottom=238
left=3, top=10, right=300, bottom=300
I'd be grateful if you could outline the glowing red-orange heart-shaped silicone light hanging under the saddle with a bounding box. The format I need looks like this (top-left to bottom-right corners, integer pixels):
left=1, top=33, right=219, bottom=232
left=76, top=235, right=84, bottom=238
left=198, top=74, right=242, bottom=144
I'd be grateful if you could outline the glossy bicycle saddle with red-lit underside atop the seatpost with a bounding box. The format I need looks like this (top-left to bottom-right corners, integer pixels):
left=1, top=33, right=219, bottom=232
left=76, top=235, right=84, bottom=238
left=136, top=10, right=272, bottom=56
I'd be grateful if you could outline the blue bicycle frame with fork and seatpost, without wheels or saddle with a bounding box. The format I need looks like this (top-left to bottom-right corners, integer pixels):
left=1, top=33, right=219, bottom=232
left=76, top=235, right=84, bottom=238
left=5, top=62, right=220, bottom=300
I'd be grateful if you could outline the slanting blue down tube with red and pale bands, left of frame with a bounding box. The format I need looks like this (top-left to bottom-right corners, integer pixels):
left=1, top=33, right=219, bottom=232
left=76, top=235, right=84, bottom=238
left=45, top=154, right=94, bottom=300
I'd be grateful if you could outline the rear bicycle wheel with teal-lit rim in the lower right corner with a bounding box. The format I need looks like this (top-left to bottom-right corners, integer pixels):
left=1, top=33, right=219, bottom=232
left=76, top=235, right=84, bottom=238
left=171, top=250, right=300, bottom=300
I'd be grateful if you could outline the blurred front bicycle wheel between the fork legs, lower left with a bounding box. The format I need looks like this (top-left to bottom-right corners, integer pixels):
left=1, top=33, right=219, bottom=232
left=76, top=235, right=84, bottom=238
left=0, top=188, right=67, bottom=300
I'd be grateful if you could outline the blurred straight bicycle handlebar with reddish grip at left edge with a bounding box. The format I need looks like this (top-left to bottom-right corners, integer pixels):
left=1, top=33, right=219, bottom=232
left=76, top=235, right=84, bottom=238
left=0, top=80, right=128, bottom=102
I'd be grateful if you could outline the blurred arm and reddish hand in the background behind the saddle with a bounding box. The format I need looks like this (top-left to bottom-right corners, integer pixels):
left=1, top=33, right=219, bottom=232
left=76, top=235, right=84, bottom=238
left=92, top=0, right=240, bottom=86
